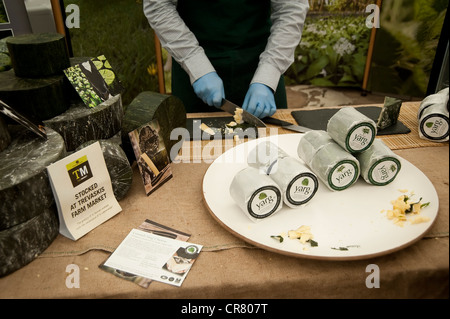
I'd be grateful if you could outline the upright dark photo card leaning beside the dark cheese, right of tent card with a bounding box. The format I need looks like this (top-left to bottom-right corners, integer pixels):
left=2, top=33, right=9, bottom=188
left=128, top=120, right=172, bottom=196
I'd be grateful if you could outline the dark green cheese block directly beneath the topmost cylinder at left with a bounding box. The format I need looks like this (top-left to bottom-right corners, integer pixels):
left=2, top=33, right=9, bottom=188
left=0, top=70, right=70, bottom=121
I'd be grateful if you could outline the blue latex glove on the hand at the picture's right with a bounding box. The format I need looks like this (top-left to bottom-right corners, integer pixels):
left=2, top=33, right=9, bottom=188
left=242, top=83, right=277, bottom=119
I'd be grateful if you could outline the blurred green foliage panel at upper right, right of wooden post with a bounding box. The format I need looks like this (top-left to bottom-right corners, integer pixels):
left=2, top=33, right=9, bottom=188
left=369, top=0, right=449, bottom=97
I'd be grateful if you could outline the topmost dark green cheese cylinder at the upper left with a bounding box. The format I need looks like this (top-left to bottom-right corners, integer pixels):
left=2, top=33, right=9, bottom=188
left=6, top=33, right=70, bottom=78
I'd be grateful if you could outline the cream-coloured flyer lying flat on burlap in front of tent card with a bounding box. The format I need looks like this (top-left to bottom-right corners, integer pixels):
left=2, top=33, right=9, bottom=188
left=104, top=229, right=203, bottom=287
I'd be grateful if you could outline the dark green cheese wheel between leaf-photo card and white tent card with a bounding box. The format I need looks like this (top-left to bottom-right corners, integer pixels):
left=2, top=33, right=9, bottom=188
left=44, top=95, right=123, bottom=152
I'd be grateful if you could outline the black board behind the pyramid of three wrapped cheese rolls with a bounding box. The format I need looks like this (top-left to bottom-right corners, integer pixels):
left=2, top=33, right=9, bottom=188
left=291, top=106, right=411, bottom=135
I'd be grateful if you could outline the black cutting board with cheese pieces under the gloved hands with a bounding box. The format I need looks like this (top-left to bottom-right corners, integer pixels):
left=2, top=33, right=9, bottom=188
left=186, top=116, right=258, bottom=141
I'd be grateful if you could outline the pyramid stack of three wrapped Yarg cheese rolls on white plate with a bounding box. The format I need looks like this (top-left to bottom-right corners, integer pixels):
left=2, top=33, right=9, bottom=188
left=297, top=107, right=401, bottom=191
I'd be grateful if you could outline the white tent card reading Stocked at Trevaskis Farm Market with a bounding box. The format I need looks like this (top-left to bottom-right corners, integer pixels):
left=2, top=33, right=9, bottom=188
left=47, top=142, right=122, bottom=240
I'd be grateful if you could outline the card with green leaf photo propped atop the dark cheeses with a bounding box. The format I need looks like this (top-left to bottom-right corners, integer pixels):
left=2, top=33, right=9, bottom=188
left=64, top=60, right=112, bottom=108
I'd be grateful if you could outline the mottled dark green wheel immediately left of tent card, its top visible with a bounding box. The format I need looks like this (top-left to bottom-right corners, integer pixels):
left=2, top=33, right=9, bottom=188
left=0, top=128, right=66, bottom=230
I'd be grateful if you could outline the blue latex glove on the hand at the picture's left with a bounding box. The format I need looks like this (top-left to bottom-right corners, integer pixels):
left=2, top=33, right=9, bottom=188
left=192, top=72, right=225, bottom=108
